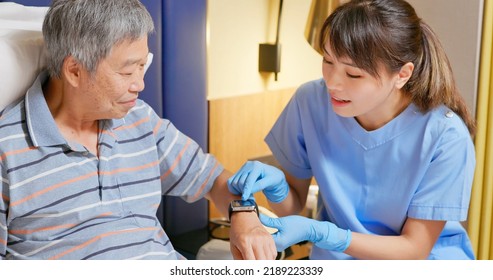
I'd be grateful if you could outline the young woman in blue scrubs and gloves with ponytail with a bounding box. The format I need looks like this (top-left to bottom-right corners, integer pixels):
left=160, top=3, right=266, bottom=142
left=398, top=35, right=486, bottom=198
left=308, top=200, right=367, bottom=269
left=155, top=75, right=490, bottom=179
left=229, top=0, right=475, bottom=259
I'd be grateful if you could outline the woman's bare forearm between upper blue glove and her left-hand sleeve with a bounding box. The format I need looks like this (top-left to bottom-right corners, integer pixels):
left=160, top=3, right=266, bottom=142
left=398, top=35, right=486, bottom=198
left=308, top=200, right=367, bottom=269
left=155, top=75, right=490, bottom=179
left=269, top=170, right=311, bottom=217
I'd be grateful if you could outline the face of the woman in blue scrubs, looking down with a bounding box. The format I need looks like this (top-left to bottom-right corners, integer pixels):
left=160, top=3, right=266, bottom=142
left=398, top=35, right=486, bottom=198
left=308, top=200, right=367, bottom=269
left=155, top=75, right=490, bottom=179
left=322, top=44, right=409, bottom=130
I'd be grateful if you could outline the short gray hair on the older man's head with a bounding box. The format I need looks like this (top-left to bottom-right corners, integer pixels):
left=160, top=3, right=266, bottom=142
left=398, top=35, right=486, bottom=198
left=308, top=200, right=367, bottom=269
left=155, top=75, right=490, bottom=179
left=43, top=0, right=154, bottom=78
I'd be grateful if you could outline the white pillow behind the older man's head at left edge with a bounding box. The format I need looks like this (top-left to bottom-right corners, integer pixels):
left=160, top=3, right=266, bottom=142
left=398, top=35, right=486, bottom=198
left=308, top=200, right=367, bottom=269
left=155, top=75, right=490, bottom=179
left=0, top=2, right=48, bottom=110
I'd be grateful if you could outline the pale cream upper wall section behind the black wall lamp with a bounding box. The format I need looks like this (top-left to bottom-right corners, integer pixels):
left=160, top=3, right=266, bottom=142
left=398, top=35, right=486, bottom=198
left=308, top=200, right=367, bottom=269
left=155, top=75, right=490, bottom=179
left=207, top=0, right=322, bottom=100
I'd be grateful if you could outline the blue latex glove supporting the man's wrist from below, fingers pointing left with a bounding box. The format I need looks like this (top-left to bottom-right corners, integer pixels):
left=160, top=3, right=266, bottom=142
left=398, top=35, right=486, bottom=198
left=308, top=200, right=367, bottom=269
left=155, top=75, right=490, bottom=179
left=260, top=214, right=351, bottom=252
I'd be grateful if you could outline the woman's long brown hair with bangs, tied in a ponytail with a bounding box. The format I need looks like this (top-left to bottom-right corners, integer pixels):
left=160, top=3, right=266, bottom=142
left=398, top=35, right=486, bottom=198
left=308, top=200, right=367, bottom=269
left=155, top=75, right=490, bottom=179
left=319, top=0, right=476, bottom=135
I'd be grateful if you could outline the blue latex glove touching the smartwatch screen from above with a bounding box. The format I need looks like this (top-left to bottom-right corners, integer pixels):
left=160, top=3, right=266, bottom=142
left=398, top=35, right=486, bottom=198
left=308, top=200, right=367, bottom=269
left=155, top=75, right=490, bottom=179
left=228, top=161, right=289, bottom=203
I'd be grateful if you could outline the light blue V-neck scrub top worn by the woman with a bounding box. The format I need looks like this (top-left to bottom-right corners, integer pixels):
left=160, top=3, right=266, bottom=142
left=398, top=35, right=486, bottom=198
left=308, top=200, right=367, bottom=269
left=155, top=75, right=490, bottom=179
left=265, top=79, right=475, bottom=259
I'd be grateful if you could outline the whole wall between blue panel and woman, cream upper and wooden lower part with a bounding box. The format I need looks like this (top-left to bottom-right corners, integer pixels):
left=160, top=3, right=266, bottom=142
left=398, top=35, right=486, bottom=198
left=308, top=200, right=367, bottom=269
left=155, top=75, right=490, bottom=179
left=207, top=0, right=322, bottom=217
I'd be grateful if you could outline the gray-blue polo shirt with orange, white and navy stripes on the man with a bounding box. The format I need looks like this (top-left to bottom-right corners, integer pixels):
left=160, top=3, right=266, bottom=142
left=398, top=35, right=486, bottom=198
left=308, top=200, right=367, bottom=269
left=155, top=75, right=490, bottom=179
left=0, top=72, right=223, bottom=259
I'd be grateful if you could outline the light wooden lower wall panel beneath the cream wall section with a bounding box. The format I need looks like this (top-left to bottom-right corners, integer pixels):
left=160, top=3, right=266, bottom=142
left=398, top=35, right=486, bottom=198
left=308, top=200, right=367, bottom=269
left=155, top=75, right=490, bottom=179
left=209, top=88, right=295, bottom=218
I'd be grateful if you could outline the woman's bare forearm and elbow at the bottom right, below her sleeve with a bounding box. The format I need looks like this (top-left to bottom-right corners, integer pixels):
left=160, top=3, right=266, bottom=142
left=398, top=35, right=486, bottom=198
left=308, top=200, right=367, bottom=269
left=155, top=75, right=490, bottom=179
left=344, top=218, right=445, bottom=260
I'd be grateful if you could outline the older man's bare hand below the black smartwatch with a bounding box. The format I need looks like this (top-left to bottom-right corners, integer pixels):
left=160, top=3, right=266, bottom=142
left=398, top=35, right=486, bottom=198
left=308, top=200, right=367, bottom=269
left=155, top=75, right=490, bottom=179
left=229, top=212, right=277, bottom=260
